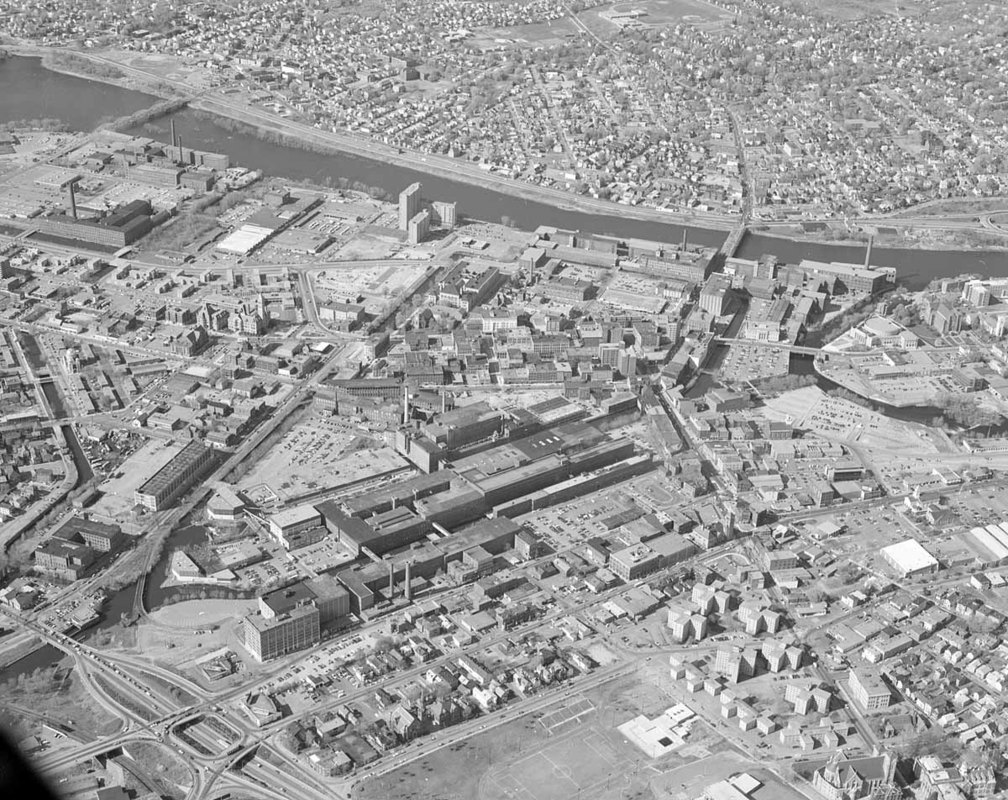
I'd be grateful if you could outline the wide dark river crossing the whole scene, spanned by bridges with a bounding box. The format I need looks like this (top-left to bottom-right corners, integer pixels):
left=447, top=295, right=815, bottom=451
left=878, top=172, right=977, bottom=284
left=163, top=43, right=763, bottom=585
left=0, top=56, right=1008, bottom=278
